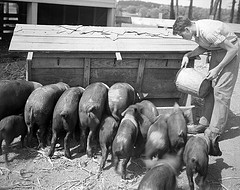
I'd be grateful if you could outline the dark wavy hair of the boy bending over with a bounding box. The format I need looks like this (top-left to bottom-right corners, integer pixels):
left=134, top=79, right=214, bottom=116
left=173, top=16, right=192, bottom=35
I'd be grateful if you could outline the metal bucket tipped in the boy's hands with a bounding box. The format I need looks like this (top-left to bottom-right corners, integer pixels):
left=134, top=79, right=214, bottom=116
left=175, top=68, right=212, bottom=98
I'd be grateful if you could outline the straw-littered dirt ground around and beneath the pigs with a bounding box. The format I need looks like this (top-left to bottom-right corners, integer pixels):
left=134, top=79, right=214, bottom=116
left=0, top=39, right=240, bottom=190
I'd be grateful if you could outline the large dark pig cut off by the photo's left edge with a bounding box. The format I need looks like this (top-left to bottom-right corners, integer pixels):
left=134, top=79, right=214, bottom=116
left=0, top=80, right=42, bottom=120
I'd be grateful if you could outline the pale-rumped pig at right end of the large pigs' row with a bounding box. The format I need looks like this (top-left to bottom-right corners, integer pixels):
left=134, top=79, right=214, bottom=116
left=107, top=83, right=139, bottom=121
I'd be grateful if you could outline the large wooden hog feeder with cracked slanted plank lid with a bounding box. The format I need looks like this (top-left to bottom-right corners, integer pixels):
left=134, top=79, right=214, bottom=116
left=9, top=24, right=196, bottom=106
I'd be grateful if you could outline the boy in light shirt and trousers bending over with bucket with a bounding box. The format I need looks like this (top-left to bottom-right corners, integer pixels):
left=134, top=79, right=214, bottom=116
left=173, top=17, right=240, bottom=156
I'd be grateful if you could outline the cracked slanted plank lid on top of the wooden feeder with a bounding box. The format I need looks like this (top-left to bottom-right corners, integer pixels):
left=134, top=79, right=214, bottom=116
left=9, top=24, right=197, bottom=52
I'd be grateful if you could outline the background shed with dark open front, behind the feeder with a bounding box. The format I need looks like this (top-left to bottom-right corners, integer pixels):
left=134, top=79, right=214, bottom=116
left=0, top=0, right=116, bottom=40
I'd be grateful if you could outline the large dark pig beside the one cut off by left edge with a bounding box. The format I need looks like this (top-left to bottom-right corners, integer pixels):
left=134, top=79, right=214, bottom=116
left=24, top=82, right=69, bottom=148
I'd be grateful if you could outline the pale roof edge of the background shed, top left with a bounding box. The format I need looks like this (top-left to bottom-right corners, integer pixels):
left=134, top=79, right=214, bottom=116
left=7, top=0, right=116, bottom=8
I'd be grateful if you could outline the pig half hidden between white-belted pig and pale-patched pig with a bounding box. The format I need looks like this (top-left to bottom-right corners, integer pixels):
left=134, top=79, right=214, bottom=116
left=131, top=100, right=158, bottom=157
